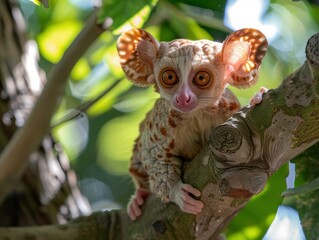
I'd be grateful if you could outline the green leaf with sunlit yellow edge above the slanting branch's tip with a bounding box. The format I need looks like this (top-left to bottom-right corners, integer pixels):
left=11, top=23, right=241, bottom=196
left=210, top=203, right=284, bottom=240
left=98, top=0, right=157, bottom=33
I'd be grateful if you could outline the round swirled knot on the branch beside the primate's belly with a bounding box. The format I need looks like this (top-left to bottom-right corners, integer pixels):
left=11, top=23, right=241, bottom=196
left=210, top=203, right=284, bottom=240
left=211, top=125, right=242, bottom=154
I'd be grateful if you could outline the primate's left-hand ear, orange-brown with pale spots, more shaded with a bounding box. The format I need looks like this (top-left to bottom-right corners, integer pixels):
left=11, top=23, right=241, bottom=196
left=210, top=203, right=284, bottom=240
left=117, top=28, right=159, bottom=87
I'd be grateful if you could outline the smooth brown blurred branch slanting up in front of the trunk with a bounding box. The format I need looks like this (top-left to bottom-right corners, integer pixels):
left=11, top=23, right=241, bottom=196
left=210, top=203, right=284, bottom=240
left=0, top=11, right=109, bottom=200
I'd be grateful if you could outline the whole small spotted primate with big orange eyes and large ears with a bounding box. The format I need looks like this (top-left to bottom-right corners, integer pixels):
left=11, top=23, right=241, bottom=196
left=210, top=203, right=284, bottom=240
left=117, top=28, right=268, bottom=220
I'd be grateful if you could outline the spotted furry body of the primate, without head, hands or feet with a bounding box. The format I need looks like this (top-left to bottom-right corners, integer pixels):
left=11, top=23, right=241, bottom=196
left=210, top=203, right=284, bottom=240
left=130, top=90, right=239, bottom=202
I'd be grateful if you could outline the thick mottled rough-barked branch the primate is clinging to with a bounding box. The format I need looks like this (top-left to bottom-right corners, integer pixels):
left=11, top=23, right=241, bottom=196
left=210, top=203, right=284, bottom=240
left=0, top=25, right=319, bottom=240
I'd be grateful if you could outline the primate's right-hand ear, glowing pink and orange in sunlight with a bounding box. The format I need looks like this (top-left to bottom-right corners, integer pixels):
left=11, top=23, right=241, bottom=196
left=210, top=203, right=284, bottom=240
left=222, top=28, right=268, bottom=88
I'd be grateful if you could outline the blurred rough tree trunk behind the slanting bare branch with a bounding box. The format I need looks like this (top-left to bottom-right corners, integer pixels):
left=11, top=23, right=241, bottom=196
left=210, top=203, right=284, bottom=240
left=0, top=0, right=91, bottom=226
